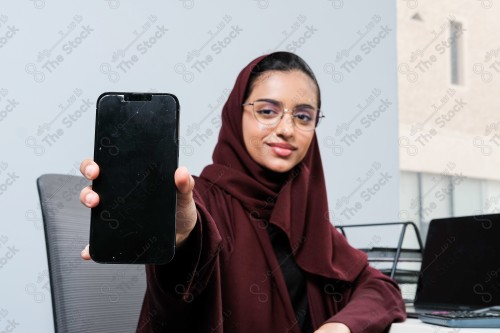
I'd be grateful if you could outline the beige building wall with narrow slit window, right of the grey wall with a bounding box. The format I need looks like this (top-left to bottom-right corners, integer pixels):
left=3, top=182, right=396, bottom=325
left=397, top=0, right=500, bottom=180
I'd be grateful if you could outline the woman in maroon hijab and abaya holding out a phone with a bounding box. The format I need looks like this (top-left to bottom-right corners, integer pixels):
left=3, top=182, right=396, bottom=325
left=81, top=52, right=405, bottom=333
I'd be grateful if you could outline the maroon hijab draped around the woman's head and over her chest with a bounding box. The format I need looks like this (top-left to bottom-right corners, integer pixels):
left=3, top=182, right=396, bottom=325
left=200, top=56, right=367, bottom=281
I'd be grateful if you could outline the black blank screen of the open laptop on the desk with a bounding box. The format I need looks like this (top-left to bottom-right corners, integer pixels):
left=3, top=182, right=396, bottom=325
left=415, top=214, right=500, bottom=309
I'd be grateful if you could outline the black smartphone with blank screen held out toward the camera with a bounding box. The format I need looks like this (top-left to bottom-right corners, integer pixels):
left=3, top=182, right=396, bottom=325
left=89, top=92, right=179, bottom=264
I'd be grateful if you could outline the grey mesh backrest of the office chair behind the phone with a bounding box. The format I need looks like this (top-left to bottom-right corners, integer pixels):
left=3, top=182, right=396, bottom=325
left=37, top=174, right=146, bottom=333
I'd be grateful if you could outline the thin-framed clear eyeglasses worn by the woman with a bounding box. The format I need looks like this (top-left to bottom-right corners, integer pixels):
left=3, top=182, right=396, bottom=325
left=243, top=100, right=325, bottom=131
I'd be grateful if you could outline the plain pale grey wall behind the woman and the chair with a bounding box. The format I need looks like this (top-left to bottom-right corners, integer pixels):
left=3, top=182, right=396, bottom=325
left=0, top=0, right=399, bottom=332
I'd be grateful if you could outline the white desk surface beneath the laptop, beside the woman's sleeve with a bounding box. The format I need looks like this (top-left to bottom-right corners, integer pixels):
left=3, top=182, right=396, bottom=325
left=389, top=318, right=500, bottom=333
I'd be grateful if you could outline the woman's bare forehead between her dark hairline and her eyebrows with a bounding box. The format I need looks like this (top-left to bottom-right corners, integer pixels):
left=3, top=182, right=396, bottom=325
left=249, top=70, right=318, bottom=105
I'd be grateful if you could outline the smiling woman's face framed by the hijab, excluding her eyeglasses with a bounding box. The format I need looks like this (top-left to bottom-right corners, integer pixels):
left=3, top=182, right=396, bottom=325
left=243, top=70, right=318, bottom=172
